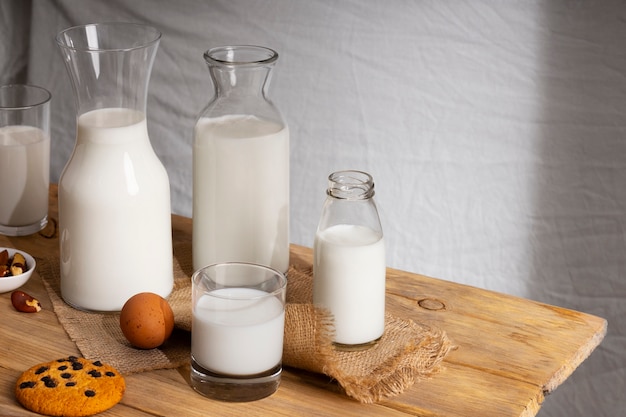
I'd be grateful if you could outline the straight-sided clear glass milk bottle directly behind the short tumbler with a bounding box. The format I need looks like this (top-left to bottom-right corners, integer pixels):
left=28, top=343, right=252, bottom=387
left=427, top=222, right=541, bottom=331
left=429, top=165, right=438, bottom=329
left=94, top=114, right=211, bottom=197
left=192, top=46, right=289, bottom=272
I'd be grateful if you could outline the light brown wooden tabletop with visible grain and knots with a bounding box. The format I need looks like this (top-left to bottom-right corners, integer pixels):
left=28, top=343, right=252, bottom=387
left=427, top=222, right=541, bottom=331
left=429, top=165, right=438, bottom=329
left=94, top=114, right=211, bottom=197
left=0, top=185, right=607, bottom=417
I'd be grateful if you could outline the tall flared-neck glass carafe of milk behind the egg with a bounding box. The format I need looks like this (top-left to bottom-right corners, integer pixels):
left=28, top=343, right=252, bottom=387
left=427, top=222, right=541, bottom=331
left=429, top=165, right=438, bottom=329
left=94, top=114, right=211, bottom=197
left=56, top=23, right=173, bottom=311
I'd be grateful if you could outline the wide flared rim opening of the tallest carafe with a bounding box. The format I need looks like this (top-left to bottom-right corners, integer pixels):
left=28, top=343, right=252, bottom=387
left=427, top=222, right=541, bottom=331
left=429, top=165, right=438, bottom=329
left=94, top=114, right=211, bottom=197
left=56, top=22, right=161, bottom=52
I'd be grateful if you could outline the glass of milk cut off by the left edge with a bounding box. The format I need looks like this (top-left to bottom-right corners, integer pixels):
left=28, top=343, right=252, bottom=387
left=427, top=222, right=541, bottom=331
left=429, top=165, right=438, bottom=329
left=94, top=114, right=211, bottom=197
left=0, top=84, right=51, bottom=236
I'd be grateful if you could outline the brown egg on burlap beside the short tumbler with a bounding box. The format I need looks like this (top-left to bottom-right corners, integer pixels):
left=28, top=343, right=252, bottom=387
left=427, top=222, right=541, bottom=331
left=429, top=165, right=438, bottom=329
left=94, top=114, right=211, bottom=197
left=120, top=292, right=174, bottom=349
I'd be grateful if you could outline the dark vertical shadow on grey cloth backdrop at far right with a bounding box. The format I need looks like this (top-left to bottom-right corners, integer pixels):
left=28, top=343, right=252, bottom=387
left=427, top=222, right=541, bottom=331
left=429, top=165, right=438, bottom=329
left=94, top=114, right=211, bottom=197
left=527, top=1, right=626, bottom=417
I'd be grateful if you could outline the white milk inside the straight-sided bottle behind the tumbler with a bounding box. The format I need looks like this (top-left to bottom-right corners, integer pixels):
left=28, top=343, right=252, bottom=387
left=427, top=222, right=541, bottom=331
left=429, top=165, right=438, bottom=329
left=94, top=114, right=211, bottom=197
left=192, top=116, right=289, bottom=272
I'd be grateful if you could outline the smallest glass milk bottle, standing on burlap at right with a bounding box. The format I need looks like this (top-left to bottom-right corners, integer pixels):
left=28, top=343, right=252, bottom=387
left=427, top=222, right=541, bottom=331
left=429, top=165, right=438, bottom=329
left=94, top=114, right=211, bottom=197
left=313, top=171, right=386, bottom=350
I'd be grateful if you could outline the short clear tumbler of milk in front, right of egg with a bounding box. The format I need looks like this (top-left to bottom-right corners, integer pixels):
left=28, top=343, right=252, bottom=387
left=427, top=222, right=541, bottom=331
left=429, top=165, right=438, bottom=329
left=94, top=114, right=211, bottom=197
left=191, top=262, right=287, bottom=402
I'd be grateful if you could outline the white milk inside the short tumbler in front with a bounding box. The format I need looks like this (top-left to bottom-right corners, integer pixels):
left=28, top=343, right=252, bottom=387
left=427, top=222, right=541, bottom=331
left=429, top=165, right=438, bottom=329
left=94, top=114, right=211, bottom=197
left=191, top=288, right=285, bottom=375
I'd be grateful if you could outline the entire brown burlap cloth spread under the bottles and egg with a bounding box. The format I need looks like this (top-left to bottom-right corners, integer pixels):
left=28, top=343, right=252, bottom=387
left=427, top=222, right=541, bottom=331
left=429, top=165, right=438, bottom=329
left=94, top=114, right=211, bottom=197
left=38, top=244, right=451, bottom=403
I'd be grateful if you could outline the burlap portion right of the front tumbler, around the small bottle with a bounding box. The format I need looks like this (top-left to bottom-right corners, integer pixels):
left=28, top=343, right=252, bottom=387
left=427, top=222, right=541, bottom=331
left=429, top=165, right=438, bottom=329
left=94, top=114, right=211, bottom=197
left=283, top=267, right=453, bottom=404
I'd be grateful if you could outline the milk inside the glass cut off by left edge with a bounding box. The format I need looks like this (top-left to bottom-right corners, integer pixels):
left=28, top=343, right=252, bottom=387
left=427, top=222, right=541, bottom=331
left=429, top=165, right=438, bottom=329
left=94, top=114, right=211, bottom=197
left=0, top=126, right=50, bottom=227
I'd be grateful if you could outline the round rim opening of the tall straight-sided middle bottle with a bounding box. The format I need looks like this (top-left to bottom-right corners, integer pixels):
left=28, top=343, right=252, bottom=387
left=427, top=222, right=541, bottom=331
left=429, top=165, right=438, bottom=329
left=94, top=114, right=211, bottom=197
left=204, top=45, right=278, bottom=66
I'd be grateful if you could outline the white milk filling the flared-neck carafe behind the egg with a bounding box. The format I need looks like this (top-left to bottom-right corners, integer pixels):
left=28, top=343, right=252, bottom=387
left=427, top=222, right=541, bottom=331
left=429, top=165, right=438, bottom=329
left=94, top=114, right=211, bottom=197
left=59, top=109, right=173, bottom=311
